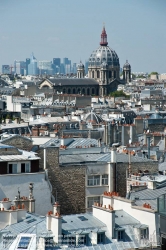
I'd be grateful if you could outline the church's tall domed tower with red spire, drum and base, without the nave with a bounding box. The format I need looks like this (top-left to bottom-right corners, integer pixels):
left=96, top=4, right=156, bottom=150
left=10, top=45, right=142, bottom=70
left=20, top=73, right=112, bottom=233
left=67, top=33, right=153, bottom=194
left=88, top=27, right=120, bottom=96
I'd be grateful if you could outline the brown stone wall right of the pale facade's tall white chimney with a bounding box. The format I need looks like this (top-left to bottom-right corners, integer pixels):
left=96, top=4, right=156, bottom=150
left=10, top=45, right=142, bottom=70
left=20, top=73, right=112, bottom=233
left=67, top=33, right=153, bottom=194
left=116, top=161, right=158, bottom=197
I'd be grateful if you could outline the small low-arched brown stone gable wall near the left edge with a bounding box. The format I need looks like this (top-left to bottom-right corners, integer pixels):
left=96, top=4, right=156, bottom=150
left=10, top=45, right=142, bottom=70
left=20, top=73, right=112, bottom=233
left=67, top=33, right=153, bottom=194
left=1, top=135, right=33, bottom=151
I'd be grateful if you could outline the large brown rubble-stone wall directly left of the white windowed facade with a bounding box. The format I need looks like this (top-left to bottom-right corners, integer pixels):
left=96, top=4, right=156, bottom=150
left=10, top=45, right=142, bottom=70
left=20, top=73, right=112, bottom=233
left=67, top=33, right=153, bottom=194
left=38, top=147, right=85, bottom=214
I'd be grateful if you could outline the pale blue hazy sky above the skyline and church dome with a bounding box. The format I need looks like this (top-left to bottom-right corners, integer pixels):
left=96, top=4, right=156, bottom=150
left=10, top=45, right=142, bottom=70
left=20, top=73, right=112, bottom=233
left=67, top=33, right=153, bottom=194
left=0, top=0, right=166, bottom=73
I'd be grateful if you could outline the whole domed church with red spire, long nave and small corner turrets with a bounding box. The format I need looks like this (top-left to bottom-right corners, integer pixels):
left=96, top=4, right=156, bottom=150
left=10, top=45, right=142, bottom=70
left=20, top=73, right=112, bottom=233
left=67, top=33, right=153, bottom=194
left=38, top=27, right=128, bottom=96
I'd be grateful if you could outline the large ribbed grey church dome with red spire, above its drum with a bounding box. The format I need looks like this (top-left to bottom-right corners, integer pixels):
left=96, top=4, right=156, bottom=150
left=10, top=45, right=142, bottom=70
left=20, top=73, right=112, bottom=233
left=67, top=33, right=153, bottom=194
left=89, top=27, right=119, bottom=66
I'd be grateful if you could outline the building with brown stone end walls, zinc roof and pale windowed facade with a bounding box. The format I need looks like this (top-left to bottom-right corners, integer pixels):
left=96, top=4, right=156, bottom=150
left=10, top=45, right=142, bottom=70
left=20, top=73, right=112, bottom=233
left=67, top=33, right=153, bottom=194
left=36, top=145, right=158, bottom=214
